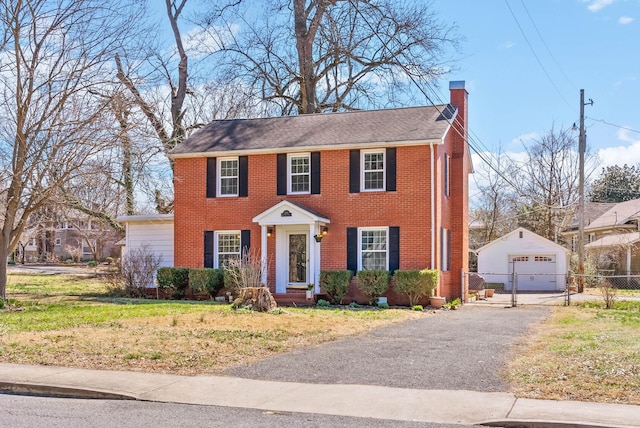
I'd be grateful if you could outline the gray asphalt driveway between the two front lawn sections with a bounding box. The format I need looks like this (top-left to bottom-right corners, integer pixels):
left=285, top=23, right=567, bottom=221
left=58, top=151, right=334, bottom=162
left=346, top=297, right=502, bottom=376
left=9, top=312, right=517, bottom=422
left=226, top=305, right=551, bottom=391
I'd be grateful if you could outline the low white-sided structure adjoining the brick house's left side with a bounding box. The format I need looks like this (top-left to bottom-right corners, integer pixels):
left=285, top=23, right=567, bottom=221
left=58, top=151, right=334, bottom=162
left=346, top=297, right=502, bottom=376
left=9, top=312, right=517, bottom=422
left=117, top=214, right=174, bottom=267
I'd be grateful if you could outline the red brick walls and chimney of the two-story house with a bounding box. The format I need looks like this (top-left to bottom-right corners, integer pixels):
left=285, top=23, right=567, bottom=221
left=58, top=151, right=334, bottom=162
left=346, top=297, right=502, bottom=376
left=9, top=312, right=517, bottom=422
left=174, top=89, right=469, bottom=300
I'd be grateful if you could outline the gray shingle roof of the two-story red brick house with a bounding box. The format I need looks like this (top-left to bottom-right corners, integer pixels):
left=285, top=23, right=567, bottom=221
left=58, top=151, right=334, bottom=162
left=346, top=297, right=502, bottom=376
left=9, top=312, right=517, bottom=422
left=171, top=105, right=456, bottom=157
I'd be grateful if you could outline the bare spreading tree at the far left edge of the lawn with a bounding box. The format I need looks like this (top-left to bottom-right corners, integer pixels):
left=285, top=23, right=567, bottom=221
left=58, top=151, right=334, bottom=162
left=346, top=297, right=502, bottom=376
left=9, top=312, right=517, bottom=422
left=0, top=0, right=139, bottom=299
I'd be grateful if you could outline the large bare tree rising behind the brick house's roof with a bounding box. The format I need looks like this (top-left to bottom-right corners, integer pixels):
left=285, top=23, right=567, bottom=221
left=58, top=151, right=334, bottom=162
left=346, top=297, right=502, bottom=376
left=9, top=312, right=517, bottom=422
left=198, top=0, right=458, bottom=114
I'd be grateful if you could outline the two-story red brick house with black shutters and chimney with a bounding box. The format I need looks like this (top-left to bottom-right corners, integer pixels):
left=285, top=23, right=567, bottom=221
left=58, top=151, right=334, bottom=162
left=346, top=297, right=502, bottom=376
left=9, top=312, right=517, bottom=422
left=171, top=81, right=471, bottom=304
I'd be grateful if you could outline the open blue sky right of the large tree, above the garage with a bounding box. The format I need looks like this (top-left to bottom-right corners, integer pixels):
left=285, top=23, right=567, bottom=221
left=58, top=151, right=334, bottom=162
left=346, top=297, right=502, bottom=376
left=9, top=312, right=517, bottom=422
left=434, top=0, right=640, bottom=172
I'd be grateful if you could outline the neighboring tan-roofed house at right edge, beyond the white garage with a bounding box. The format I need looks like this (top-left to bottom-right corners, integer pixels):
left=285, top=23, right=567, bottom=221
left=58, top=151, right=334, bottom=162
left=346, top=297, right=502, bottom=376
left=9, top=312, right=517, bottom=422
left=565, top=199, right=640, bottom=275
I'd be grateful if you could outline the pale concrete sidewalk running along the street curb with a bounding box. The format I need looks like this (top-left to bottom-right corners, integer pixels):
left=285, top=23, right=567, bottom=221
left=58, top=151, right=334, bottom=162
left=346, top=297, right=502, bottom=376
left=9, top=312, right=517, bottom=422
left=0, top=364, right=640, bottom=427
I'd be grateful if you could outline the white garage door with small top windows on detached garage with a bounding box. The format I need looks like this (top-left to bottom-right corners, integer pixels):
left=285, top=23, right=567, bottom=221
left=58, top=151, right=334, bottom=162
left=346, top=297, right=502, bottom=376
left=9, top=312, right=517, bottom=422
left=509, top=254, right=561, bottom=291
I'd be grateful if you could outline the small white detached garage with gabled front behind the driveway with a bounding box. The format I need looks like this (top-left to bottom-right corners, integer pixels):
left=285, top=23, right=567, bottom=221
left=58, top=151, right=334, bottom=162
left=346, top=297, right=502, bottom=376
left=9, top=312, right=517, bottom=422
left=477, top=227, right=571, bottom=291
